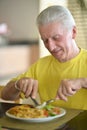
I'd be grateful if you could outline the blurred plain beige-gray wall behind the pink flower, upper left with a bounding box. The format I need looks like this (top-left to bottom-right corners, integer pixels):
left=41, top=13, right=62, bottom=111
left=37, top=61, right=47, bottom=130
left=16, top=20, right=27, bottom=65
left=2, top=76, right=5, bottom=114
left=0, top=0, right=39, bottom=40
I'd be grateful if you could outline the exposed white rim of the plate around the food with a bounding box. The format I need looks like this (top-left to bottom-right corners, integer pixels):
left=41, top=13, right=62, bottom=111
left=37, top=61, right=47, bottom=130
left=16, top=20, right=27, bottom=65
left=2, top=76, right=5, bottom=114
left=6, top=108, right=66, bottom=123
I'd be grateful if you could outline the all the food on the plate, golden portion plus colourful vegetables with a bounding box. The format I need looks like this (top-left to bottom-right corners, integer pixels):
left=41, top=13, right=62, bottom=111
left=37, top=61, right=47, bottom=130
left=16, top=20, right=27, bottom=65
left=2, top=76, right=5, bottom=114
left=8, top=104, right=60, bottom=118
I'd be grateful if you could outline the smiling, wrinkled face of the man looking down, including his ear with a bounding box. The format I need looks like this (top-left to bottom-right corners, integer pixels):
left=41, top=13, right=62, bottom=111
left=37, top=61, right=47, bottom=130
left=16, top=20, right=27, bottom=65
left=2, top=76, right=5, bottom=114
left=39, top=22, right=74, bottom=62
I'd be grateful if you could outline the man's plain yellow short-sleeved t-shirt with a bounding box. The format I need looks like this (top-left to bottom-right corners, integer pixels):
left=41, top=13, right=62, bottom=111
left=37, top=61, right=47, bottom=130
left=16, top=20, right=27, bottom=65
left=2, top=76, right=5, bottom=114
left=13, top=49, right=87, bottom=109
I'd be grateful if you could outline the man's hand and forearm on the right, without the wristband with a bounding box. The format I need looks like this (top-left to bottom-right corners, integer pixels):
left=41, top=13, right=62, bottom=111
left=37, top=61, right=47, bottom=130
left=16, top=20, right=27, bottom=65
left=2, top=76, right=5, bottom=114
left=56, top=78, right=87, bottom=101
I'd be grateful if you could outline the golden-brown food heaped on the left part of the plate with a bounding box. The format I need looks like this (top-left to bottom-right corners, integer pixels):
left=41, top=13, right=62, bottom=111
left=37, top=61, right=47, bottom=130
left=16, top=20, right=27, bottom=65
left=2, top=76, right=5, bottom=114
left=8, top=105, right=44, bottom=118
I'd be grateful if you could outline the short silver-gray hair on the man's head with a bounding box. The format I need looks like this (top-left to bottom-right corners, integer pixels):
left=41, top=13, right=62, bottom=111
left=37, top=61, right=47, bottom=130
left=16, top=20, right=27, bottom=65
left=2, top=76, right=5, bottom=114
left=36, top=5, right=75, bottom=29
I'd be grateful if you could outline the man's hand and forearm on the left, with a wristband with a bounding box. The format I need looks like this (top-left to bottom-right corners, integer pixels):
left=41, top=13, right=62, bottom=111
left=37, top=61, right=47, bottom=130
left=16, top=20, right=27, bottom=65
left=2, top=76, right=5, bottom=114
left=1, top=78, right=38, bottom=100
